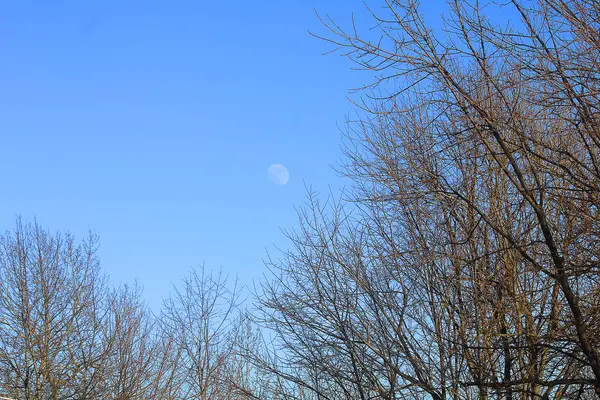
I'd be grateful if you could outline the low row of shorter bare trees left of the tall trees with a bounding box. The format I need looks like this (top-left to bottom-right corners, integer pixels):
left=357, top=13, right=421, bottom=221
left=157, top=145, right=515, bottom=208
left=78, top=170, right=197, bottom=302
left=0, top=220, right=268, bottom=400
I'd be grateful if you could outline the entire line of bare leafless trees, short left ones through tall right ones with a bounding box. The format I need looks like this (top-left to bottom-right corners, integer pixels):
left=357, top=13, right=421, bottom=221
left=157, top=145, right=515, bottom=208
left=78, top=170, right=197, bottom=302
left=0, top=0, right=600, bottom=400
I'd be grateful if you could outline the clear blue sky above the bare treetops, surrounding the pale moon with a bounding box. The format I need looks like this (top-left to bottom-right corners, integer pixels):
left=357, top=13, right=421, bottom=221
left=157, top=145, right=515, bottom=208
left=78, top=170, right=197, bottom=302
left=0, top=0, right=452, bottom=305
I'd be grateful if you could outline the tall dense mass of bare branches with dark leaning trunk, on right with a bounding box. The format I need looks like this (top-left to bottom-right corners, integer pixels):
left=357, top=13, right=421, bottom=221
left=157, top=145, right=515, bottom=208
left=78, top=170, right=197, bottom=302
left=262, top=0, right=600, bottom=399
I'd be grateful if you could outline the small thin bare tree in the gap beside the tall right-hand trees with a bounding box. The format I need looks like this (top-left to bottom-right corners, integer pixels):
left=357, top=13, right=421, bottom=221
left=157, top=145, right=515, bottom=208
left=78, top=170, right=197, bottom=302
left=160, top=268, right=244, bottom=399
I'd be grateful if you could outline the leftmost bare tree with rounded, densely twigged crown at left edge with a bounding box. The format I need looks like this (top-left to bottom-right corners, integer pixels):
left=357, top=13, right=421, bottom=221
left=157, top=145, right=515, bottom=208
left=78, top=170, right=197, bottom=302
left=0, top=220, right=108, bottom=399
